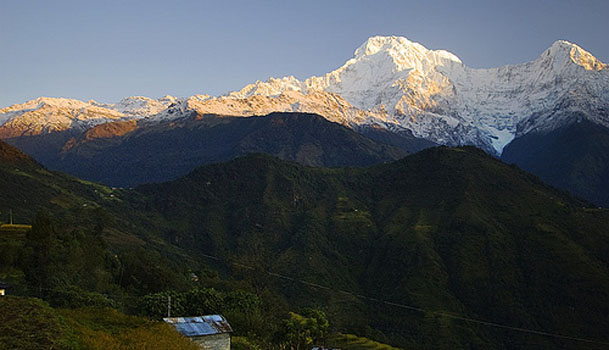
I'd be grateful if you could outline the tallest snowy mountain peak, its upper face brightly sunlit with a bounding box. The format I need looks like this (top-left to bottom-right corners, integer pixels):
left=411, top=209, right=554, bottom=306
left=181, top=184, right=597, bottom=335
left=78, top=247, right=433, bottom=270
left=305, top=36, right=462, bottom=114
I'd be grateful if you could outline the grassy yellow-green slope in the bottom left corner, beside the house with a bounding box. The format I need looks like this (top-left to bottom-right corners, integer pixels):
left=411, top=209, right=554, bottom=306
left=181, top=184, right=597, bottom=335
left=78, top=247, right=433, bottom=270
left=0, top=296, right=197, bottom=350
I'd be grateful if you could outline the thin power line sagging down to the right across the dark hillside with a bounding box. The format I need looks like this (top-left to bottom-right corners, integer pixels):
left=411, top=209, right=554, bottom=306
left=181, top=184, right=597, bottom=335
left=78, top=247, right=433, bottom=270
left=199, top=253, right=609, bottom=346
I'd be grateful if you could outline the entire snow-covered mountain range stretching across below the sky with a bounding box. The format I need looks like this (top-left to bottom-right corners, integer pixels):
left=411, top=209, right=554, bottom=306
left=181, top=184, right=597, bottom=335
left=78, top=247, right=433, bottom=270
left=0, top=36, right=609, bottom=154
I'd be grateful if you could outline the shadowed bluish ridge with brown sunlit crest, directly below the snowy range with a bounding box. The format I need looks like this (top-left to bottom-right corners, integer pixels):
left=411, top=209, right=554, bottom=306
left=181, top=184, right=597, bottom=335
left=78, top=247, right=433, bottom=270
left=5, top=113, right=408, bottom=187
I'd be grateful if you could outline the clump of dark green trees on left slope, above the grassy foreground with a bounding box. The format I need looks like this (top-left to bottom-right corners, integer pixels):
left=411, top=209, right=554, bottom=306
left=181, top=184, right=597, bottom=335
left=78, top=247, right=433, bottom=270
left=16, top=212, right=186, bottom=307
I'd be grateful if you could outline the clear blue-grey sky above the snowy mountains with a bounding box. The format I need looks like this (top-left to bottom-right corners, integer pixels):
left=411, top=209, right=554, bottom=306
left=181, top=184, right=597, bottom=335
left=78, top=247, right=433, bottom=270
left=0, top=0, right=609, bottom=107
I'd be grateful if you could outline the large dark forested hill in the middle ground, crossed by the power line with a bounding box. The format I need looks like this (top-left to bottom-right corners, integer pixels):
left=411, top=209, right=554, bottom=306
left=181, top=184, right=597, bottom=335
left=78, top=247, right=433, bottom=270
left=138, top=148, right=609, bottom=349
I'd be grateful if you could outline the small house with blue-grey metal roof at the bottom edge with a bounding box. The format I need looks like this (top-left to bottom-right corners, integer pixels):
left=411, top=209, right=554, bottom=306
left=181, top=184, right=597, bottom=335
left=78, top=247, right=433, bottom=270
left=163, top=315, right=233, bottom=350
